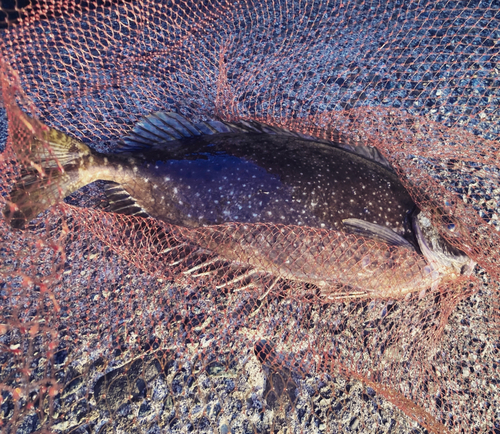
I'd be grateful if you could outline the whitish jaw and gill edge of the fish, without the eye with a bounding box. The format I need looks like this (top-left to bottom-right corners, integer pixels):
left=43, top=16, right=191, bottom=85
left=413, top=211, right=476, bottom=277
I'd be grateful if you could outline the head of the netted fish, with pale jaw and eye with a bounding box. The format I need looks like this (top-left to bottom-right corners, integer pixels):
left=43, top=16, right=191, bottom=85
left=413, top=211, right=476, bottom=277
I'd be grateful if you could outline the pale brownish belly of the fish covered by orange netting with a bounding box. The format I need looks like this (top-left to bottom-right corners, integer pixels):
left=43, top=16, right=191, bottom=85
left=192, top=223, right=441, bottom=300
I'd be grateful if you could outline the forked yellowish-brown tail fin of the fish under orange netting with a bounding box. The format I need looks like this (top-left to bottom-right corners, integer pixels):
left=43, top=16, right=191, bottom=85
left=3, top=106, right=91, bottom=228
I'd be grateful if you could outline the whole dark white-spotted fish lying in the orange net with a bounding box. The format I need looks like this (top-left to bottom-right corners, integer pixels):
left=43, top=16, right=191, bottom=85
left=3, top=107, right=475, bottom=297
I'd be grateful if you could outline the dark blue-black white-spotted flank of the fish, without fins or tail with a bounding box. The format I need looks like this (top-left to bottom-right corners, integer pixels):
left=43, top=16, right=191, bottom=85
left=117, top=132, right=415, bottom=242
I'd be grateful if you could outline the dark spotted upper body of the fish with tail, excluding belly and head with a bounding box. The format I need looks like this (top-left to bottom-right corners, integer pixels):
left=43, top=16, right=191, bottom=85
left=4, top=105, right=416, bottom=236
